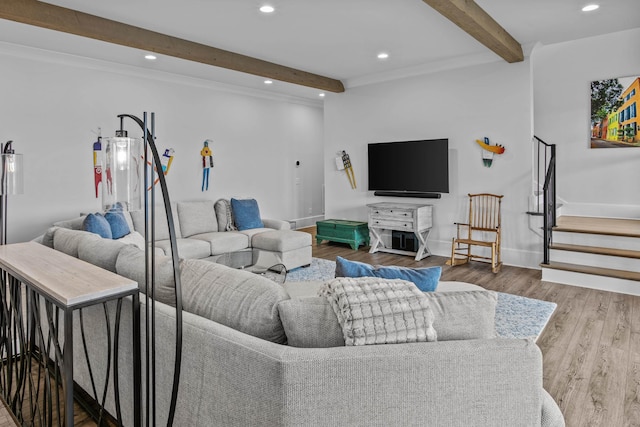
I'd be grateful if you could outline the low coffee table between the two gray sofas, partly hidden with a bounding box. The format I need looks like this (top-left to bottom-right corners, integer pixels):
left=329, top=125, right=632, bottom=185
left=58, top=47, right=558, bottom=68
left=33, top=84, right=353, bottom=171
left=215, top=249, right=287, bottom=284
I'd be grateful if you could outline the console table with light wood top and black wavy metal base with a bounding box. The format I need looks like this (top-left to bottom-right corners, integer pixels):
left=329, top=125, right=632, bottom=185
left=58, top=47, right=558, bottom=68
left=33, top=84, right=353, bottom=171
left=0, top=242, right=140, bottom=427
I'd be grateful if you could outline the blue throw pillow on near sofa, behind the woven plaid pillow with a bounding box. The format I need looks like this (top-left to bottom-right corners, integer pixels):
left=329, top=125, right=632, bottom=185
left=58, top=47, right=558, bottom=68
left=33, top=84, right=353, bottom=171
left=336, top=257, right=442, bottom=292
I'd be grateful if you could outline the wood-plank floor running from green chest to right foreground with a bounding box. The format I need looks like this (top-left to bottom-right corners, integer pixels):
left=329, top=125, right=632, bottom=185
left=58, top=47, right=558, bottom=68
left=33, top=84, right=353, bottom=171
left=304, top=228, right=640, bottom=427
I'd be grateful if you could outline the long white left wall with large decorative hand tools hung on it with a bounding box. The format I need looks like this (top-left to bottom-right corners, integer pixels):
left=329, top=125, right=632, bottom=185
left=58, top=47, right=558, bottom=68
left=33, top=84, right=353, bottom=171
left=0, top=44, right=323, bottom=242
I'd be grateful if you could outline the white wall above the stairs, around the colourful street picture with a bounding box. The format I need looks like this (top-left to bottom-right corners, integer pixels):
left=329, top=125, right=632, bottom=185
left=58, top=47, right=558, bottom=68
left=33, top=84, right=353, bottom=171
left=531, top=28, right=640, bottom=212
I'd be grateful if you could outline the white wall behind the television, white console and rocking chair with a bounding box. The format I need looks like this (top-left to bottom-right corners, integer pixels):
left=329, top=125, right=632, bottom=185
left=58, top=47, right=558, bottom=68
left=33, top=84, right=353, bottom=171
left=324, top=61, right=540, bottom=266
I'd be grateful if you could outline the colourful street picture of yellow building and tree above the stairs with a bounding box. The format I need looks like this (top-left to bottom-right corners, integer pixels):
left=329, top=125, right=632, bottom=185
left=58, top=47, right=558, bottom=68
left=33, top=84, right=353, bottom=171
left=590, top=76, right=640, bottom=148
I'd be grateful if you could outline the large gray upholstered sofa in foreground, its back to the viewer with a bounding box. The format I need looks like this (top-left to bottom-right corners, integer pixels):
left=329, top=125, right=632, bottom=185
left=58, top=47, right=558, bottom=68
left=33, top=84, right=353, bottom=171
left=43, top=228, right=564, bottom=427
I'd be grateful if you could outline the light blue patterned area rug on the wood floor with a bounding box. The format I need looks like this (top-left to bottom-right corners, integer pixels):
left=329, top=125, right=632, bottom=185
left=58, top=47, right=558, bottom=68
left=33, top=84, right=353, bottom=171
left=287, top=258, right=556, bottom=338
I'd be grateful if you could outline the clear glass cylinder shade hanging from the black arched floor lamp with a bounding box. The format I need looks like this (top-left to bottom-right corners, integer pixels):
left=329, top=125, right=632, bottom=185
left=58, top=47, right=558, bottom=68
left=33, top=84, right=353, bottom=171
left=102, top=136, right=143, bottom=210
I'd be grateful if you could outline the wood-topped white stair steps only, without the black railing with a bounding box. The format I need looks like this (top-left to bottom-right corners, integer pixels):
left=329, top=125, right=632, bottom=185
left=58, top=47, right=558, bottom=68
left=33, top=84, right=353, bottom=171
left=540, top=216, right=640, bottom=295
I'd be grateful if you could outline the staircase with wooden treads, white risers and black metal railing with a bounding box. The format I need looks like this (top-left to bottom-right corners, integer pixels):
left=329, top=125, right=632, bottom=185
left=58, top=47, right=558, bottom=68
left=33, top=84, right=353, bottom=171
left=528, top=136, right=640, bottom=295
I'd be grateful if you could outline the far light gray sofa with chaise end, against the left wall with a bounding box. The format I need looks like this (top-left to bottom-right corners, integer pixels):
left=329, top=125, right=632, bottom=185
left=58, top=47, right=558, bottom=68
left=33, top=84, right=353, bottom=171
left=45, top=199, right=311, bottom=270
